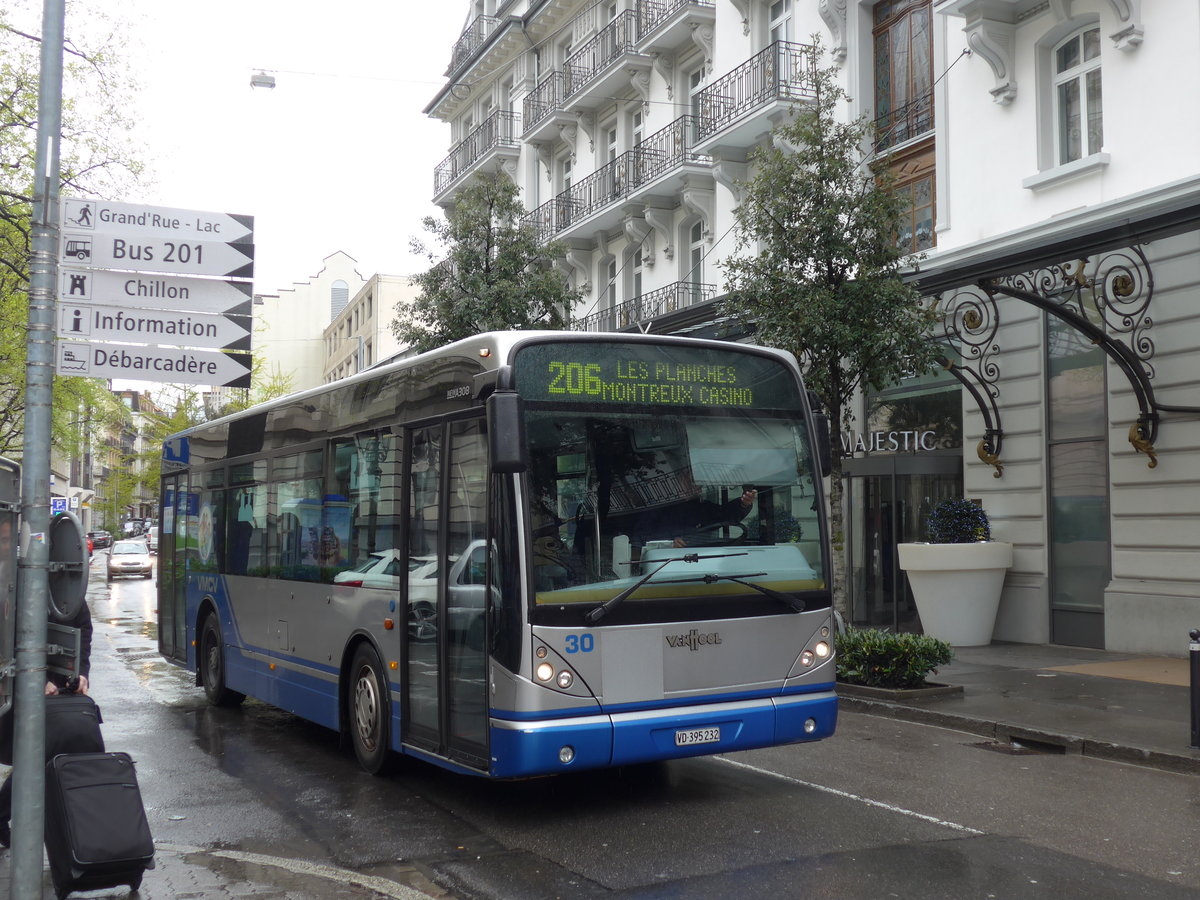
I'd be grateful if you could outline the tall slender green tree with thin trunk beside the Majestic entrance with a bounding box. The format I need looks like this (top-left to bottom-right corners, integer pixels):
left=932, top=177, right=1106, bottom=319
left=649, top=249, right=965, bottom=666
left=725, top=52, right=941, bottom=614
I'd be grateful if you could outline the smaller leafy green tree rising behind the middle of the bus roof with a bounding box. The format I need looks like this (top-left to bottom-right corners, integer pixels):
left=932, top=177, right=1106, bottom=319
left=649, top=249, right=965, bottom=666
left=391, top=173, right=580, bottom=352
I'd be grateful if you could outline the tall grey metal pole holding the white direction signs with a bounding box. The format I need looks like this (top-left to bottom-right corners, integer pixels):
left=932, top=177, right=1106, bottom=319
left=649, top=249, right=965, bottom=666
left=10, top=0, right=65, bottom=900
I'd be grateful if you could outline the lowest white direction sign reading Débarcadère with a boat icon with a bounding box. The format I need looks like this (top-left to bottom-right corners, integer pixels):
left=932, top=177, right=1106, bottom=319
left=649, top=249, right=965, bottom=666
left=55, top=341, right=252, bottom=388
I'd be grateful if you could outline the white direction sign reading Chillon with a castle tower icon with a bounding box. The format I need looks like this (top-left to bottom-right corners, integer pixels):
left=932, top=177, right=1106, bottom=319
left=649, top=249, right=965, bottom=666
left=59, top=269, right=253, bottom=316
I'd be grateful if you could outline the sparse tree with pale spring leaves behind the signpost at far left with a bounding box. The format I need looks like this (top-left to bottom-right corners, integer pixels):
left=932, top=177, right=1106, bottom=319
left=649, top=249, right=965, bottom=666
left=0, top=0, right=140, bottom=457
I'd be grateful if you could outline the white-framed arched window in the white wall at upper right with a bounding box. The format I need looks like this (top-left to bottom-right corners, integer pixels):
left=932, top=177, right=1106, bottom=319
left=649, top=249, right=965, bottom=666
left=1054, top=28, right=1104, bottom=166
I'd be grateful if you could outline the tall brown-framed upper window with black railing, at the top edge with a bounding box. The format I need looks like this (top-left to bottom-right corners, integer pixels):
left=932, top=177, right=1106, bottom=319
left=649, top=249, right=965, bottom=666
left=872, top=0, right=934, bottom=150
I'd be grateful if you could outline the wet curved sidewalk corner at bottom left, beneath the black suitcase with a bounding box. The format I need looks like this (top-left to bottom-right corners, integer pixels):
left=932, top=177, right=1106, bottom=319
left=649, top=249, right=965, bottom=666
left=0, top=842, right=450, bottom=900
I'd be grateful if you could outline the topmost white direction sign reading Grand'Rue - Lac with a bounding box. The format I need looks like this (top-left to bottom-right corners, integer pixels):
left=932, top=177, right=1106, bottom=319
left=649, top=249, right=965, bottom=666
left=59, top=197, right=254, bottom=244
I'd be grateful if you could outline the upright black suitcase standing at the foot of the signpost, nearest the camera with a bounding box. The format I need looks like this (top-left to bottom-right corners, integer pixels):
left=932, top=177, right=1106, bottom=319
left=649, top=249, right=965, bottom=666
left=46, top=754, right=154, bottom=900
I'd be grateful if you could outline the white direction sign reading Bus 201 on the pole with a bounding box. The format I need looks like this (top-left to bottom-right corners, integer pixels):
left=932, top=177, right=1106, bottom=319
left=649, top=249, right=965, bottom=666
left=59, top=229, right=254, bottom=278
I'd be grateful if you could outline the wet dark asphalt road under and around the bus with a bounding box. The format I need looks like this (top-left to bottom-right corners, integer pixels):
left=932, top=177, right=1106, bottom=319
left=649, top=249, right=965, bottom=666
left=89, top=553, right=1200, bottom=900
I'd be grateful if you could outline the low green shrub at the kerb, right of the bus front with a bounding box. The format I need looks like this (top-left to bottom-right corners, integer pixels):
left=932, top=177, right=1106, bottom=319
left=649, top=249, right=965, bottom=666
left=836, top=628, right=954, bottom=689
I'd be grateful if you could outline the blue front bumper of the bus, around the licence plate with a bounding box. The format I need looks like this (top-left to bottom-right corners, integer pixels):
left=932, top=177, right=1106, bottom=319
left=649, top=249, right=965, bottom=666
left=491, top=685, right=838, bottom=778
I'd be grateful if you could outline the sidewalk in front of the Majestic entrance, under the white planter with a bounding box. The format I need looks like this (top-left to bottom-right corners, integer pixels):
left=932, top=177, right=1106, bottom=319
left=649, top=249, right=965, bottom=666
left=838, top=643, right=1200, bottom=774
